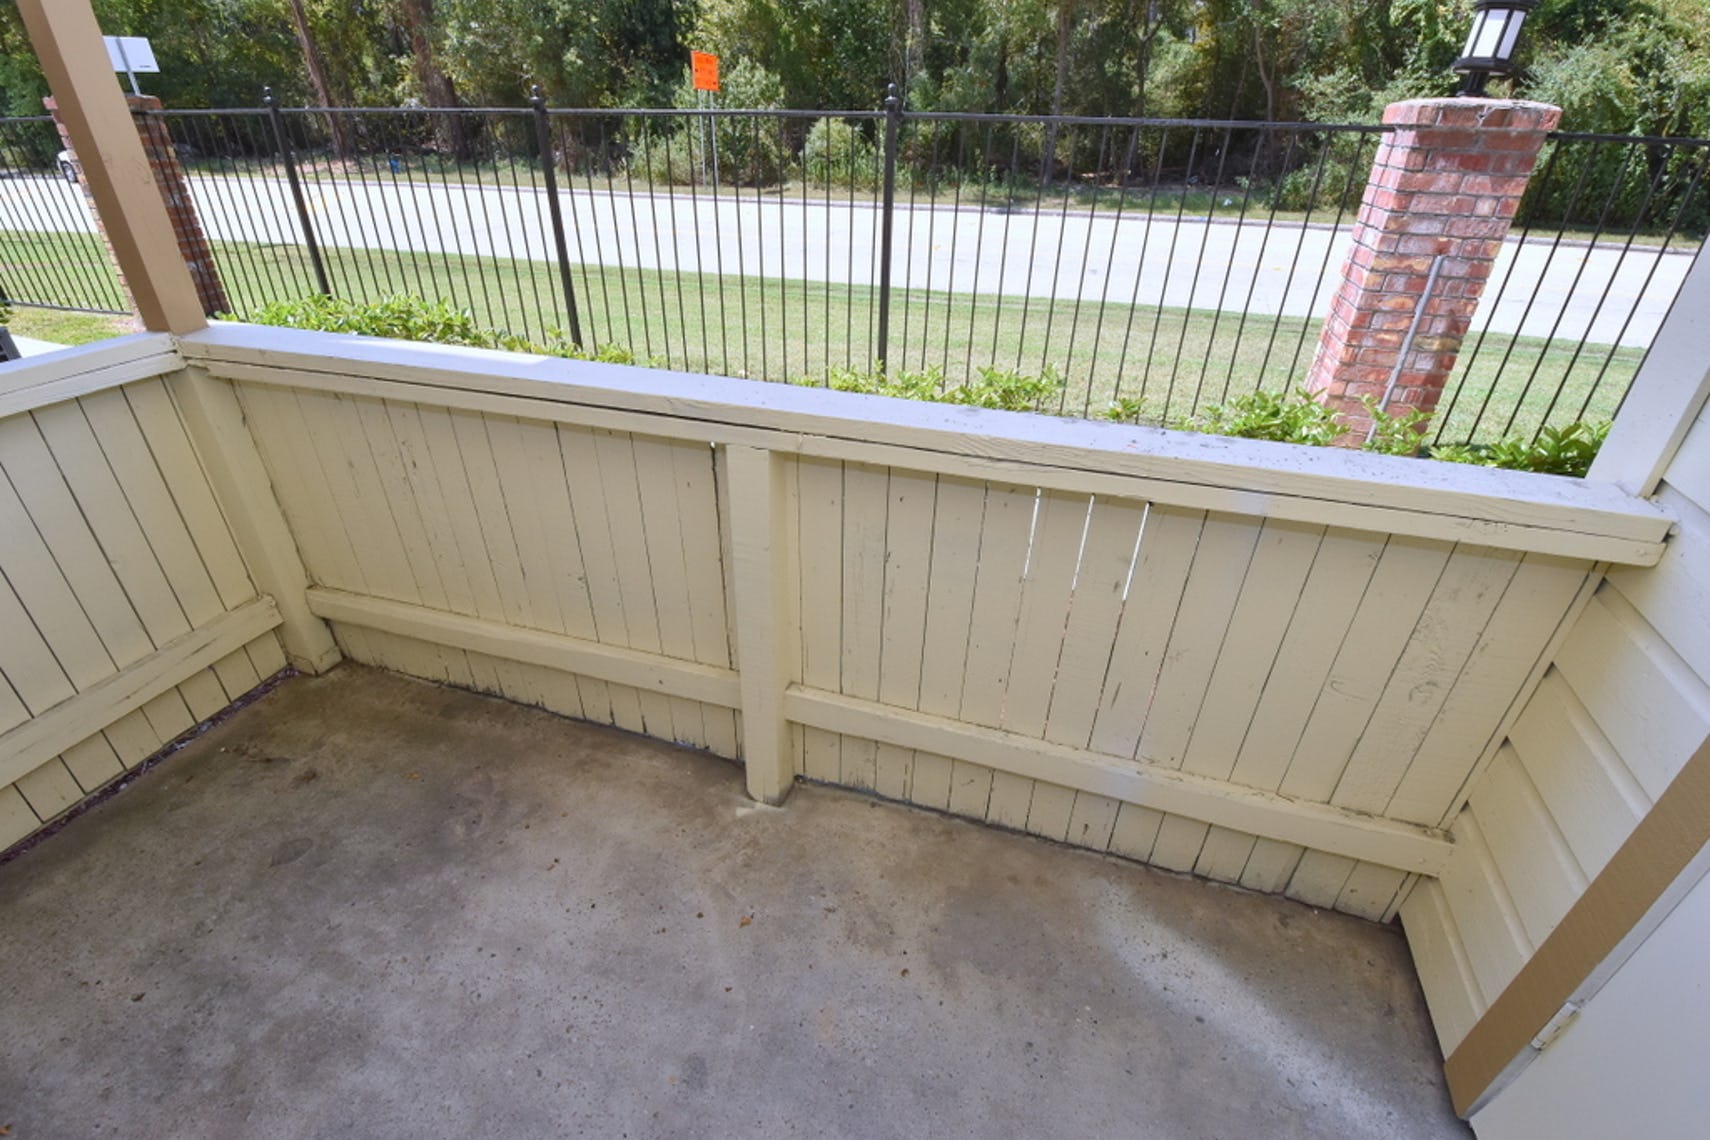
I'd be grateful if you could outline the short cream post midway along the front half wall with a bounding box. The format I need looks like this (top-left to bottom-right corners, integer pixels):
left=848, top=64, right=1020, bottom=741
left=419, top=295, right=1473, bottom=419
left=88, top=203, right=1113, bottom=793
left=723, top=444, right=797, bottom=803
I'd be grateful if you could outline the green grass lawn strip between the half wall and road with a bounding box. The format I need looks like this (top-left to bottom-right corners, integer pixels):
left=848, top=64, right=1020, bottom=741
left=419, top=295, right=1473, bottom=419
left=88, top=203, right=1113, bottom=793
left=0, top=225, right=1643, bottom=443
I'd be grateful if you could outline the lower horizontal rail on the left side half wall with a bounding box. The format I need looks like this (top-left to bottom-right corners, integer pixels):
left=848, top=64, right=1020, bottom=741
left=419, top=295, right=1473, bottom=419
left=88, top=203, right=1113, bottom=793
left=0, top=598, right=280, bottom=784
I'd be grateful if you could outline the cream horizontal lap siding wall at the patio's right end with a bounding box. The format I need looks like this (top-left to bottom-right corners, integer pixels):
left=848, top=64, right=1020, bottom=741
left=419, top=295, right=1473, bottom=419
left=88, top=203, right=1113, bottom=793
left=1400, top=399, right=1710, bottom=1055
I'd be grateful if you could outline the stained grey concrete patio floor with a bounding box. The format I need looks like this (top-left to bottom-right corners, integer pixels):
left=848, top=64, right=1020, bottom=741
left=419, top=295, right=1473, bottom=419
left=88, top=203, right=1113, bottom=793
left=0, top=665, right=1469, bottom=1140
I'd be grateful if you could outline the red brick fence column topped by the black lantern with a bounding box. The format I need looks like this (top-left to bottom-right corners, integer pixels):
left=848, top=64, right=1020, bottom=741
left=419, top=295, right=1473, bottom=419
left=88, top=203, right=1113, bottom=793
left=1306, top=99, right=1561, bottom=446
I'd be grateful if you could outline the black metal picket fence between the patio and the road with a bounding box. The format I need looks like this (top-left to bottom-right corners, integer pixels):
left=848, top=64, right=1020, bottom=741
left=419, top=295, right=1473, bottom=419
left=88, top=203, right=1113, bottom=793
left=0, top=103, right=1710, bottom=441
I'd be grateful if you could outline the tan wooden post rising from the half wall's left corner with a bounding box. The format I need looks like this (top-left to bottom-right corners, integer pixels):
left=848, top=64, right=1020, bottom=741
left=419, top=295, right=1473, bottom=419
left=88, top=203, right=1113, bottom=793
left=17, top=0, right=207, bottom=333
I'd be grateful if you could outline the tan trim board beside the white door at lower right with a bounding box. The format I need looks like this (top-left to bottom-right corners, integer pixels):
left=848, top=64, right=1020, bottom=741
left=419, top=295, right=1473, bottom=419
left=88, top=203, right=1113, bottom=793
left=1443, top=740, right=1710, bottom=1116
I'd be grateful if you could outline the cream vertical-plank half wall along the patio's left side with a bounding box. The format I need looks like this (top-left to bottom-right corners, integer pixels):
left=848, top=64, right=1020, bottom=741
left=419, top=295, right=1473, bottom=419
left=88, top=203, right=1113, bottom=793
left=0, top=337, right=286, bottom=849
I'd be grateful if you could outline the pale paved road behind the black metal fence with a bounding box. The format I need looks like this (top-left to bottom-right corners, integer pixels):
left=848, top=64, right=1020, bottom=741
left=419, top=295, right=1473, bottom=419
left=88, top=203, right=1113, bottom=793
left=0, top=176, right=1691, bottom=347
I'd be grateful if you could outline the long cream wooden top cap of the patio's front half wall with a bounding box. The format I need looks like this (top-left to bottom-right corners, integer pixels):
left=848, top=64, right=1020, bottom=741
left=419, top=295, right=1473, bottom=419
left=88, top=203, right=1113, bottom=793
left=178, top=321, right=1672, bottom=566
